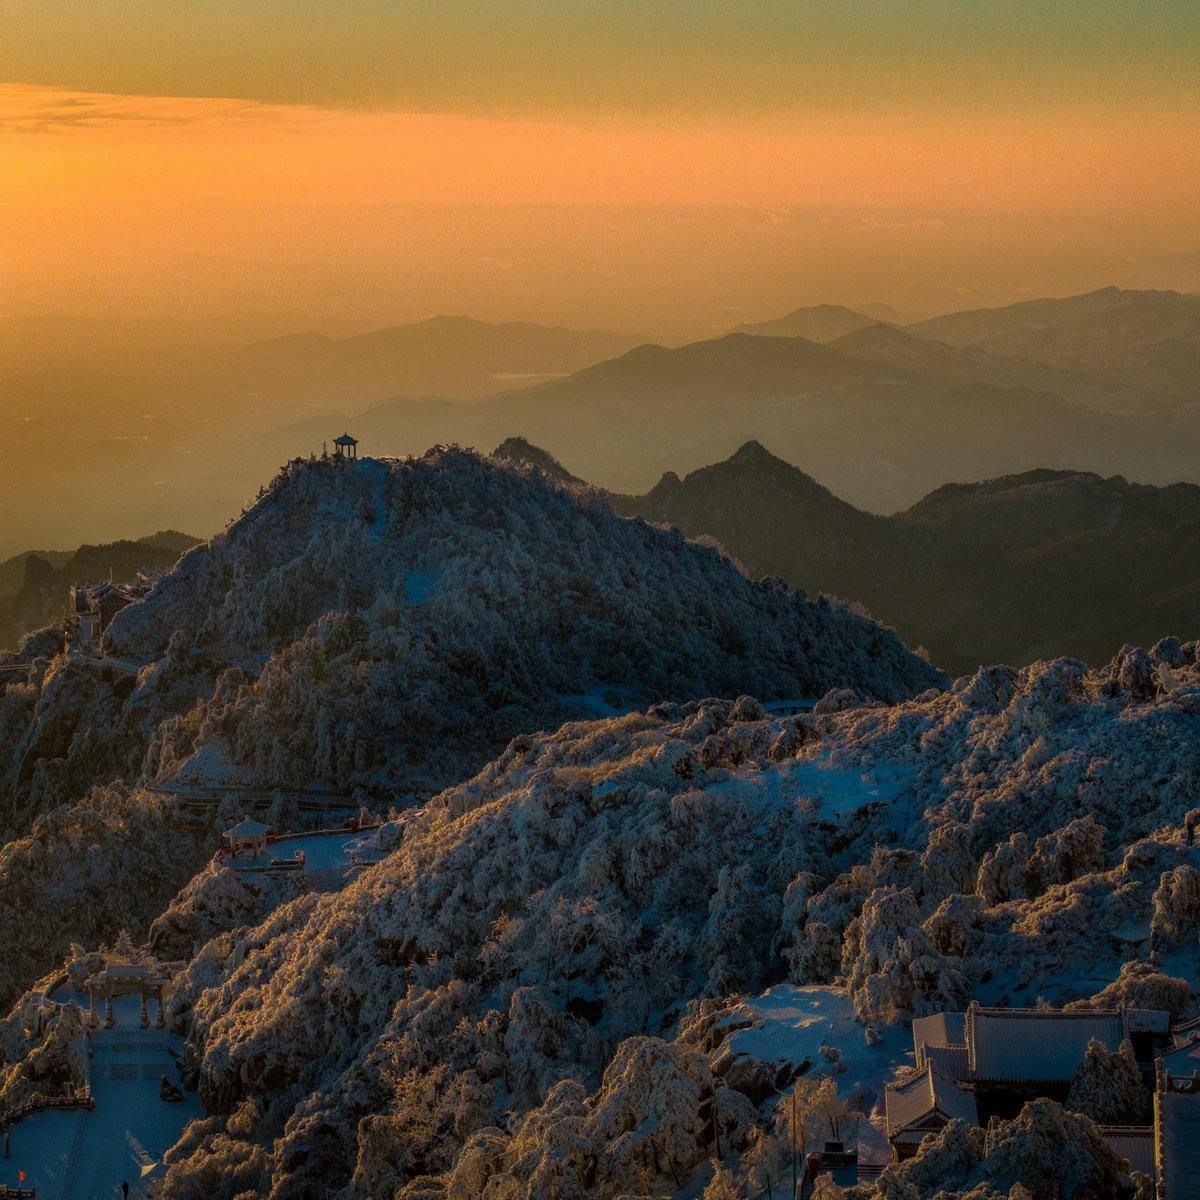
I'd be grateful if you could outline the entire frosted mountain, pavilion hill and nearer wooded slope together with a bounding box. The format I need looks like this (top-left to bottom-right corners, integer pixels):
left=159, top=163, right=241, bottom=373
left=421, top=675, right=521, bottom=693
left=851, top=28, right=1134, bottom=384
left=0, top=445, right=1200, bottom=1200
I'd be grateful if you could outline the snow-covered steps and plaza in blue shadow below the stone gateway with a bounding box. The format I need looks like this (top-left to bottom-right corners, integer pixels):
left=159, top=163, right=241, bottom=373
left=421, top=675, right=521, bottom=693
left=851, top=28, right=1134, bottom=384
left=0, top=996, right=202, bottom=1200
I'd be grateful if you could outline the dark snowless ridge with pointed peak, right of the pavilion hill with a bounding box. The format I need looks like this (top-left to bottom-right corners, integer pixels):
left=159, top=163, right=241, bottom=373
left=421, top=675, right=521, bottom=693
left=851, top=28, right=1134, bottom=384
left=509, top=442, right=1200, bottom=674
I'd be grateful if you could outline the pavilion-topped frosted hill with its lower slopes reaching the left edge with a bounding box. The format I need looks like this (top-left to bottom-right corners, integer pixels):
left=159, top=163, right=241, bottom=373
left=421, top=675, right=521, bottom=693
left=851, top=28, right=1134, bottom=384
left=0, top=449, right=944, bottom=1008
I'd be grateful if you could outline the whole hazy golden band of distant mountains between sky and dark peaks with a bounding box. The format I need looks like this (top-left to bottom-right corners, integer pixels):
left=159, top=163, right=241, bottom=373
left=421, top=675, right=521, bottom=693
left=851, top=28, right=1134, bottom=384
left=9, top=289, right=1200, bottom=551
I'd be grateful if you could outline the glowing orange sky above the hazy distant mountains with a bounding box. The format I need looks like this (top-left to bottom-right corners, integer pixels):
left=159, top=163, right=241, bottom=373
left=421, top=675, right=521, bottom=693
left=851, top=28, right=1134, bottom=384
left=0, top=0, right=1200, bottom=353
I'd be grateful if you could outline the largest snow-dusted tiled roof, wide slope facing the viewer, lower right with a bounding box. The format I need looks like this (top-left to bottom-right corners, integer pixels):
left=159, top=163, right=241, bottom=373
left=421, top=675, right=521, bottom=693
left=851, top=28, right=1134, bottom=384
left=966, top=1004, right=1126, bottom=1084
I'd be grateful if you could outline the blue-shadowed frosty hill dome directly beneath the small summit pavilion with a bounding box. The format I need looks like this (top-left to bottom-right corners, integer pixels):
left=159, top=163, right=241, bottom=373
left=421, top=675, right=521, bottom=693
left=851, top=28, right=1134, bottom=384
left=108, top=449, right=938, bottom=786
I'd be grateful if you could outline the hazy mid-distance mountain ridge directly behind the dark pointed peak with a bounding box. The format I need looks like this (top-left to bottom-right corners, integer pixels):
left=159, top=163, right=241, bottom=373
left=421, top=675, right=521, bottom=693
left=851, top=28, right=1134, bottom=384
left=290, top=329, right=1198, bottom=512
